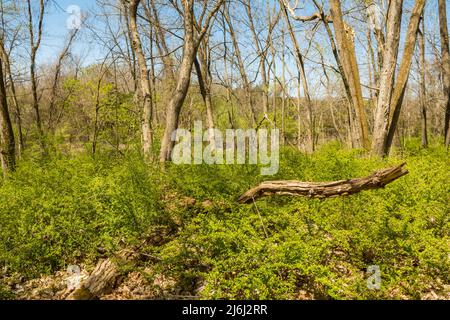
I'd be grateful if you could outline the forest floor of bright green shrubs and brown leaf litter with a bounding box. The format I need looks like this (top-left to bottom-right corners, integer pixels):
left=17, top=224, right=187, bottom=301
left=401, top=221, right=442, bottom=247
left=0, top=140, right=450, bottom=299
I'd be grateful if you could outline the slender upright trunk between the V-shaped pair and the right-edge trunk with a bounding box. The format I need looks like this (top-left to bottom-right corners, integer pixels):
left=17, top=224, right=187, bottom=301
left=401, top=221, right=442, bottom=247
left=419, top=15, right=428, bottom=148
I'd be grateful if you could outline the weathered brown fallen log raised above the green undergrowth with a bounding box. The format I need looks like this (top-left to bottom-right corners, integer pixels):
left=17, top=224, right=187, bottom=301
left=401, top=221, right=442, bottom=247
left=238, top=162, right=408, bottom=203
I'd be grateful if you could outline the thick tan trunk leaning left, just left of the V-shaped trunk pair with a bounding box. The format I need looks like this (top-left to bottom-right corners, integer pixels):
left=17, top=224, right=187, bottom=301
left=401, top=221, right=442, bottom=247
left=330, top=0, right=370, bottom=150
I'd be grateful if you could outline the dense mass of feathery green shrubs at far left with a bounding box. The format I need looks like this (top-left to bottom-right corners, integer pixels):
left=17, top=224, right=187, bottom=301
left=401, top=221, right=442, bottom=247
left=0, top=152, right=165, bottom=276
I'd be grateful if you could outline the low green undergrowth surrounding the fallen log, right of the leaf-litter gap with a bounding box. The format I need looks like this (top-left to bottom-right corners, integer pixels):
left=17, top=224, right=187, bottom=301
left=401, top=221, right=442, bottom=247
left=156, top=144, right=450, bottom=299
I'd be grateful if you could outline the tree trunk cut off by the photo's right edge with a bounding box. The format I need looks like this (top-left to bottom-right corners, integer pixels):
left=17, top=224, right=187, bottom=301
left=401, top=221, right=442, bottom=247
left=439, top=0, right=450, bottom=147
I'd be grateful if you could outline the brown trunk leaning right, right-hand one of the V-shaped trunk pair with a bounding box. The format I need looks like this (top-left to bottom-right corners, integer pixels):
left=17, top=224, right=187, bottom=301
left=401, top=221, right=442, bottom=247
left=382, top=0, right=425, bottom=156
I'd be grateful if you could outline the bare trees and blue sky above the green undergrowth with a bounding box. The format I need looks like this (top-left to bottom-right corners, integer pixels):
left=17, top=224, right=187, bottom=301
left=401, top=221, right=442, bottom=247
left=0, top=0, right=450, bottom=172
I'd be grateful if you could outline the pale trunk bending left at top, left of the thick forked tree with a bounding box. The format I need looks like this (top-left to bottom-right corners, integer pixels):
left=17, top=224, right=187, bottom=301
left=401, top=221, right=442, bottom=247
left=123, top=0, right=153, bottom=158
